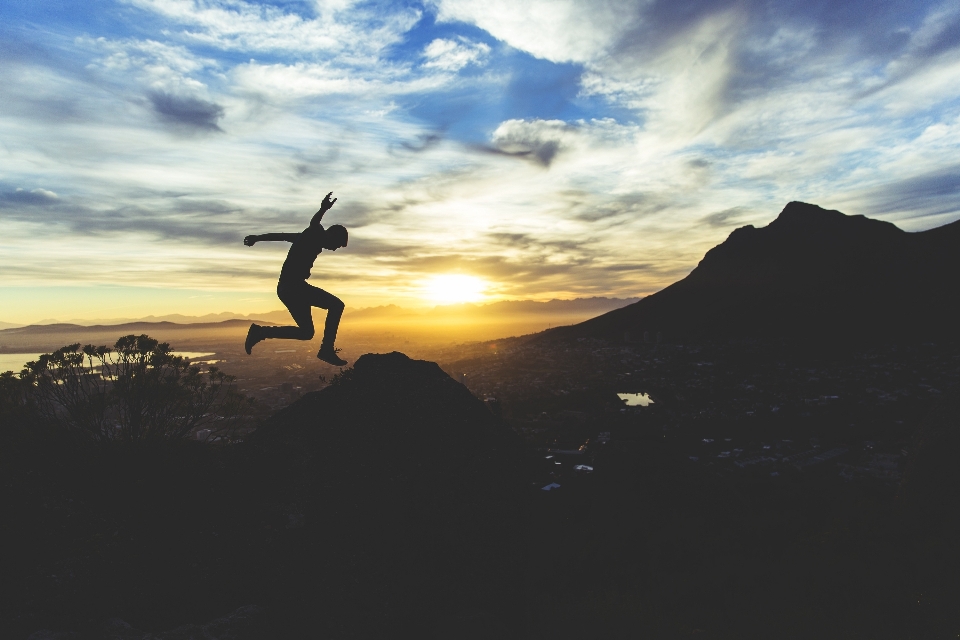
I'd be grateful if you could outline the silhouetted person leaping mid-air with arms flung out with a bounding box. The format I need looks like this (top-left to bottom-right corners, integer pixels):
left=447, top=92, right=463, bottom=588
left=243, top=191, right=347, bottom=367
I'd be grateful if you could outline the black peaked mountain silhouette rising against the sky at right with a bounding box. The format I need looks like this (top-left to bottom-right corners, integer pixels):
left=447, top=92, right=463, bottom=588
left=547, top=202, right=960, bottom=340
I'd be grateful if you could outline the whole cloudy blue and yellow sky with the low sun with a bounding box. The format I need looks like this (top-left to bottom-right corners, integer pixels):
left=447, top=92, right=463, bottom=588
left=0, top=0, right=960, bottom=323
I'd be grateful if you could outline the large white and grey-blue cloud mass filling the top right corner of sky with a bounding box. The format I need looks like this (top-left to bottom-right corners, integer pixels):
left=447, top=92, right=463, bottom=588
left=437, top=0, right=960, bottom=154
